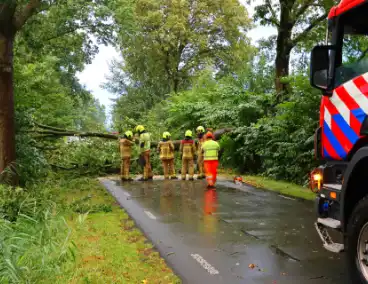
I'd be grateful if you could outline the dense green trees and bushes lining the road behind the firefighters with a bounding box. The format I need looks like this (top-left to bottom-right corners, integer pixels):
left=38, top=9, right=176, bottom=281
left=0, top=0, right=366, bottom=186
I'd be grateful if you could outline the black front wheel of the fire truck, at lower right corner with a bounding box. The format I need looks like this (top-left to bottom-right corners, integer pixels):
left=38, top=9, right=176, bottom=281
left=345, top=196, right=368, bottom=284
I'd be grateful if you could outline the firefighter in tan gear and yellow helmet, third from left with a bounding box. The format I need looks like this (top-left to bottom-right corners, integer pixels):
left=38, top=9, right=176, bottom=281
left=157, top=132, right=177, bottom=179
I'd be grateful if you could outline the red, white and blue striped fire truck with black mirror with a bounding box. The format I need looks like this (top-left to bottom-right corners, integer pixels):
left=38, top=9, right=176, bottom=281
left=310, top=0, right=368, bottom=284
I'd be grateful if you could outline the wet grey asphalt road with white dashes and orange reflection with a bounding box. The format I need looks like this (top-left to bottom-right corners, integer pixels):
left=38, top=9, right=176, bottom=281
left=101, top=179, right=347, bottom=284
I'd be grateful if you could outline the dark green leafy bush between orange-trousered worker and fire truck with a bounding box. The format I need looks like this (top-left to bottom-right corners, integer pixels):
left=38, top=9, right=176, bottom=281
left=224, top=74, right=320, bottom=184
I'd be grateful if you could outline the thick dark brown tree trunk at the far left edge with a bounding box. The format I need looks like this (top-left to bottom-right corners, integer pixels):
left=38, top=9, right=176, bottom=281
left=0, top=33, right=16, bottom=180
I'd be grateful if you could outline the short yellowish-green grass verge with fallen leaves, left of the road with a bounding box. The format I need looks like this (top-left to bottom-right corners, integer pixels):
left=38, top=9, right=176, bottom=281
left=54, top=176, right=180, bottom=284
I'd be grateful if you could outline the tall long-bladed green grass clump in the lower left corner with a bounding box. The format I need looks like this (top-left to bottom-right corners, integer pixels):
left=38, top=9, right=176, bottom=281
left=0, top=182, right=74, bottom=283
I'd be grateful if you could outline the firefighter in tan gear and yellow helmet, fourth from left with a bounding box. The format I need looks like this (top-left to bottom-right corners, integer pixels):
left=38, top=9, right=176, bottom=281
left=180, top=130, right=196, bottom=180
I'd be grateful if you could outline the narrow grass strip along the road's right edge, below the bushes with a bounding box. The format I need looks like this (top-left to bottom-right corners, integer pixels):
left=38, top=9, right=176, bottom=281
left=219, top=169, right=316, bottom=200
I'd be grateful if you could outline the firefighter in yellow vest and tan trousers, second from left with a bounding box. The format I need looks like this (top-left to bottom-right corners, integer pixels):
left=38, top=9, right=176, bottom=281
left=135, top=125, right=153, bottom=181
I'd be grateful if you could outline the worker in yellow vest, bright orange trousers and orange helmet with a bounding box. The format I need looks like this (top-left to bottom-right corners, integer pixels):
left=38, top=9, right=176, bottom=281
left=202, top=132, right=220, bottom=188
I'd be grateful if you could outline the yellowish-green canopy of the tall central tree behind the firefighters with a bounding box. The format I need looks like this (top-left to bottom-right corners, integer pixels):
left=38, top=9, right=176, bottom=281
left=105, top=0, right=254, bottom=131
